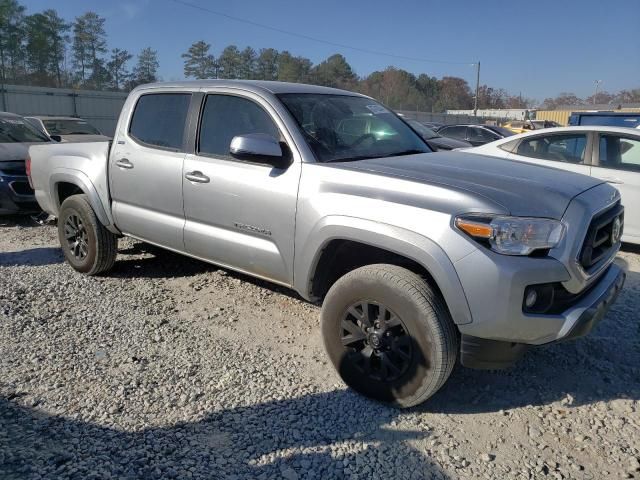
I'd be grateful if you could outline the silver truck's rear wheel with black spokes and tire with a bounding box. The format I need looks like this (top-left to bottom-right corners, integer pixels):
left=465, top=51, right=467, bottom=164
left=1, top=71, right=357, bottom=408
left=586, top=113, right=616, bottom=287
left=58, top=195, right=118, bottom=275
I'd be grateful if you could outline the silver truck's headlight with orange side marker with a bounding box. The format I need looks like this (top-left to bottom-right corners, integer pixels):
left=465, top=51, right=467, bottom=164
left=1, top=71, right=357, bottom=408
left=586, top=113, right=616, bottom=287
left=455, top=215, right=564, bottom=255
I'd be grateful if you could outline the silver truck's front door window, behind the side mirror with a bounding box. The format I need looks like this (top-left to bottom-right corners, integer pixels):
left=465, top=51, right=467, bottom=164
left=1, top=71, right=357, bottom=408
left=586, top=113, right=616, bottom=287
left=198, top=95, right=280, bottom=157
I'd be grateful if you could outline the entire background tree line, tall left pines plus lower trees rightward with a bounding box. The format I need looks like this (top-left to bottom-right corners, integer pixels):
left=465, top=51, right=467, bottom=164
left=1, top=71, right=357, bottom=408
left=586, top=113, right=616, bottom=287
left=0, top=0, right=640, bottom=112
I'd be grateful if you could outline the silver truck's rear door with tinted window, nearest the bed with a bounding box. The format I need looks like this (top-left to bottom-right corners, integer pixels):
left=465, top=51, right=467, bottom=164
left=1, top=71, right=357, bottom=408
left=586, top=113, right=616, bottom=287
left=109, top=92, right=191, bottom=250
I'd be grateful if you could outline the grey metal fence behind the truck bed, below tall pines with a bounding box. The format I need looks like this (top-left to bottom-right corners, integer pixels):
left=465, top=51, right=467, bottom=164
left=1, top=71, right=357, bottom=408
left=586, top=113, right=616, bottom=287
left=0, top=85, right=127, bottom=136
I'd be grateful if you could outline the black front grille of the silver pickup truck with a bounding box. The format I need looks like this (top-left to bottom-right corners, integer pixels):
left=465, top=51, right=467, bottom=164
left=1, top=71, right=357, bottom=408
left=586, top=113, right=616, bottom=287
left=579, top=202, right=624, bottom=271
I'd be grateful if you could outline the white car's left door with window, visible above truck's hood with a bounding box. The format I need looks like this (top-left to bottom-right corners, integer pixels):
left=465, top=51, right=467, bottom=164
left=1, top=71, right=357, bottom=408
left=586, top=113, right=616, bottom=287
left=508, top=131, right=591, bottom=175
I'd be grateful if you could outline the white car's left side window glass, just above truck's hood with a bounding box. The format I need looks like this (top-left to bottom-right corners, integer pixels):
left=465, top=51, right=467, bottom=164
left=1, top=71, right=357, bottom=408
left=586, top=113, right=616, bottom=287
left=516, top=134, right=587, bottom=163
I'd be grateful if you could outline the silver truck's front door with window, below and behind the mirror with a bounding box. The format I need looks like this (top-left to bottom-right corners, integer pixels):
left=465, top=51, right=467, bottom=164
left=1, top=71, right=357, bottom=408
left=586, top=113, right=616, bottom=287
left=183, top=93, right=301, bottom=285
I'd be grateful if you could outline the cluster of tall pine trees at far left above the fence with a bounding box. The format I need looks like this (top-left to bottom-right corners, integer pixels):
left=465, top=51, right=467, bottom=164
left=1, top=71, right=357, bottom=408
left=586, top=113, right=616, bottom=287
left=0, top=0, right=159, bottom=91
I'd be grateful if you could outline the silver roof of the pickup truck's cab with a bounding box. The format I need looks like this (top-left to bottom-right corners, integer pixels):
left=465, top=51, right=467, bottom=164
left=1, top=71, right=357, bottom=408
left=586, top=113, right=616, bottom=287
left=135, top=80, right=364, bottom=96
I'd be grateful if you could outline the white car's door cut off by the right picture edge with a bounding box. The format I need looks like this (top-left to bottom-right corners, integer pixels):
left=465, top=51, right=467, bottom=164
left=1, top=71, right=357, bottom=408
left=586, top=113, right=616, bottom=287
left=591, top=133, right=640, bottom=243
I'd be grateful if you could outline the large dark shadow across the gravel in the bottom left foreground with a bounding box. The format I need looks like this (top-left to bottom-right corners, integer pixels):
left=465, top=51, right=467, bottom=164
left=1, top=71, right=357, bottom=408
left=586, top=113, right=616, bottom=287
left=0, top=390, right=449, bottom=479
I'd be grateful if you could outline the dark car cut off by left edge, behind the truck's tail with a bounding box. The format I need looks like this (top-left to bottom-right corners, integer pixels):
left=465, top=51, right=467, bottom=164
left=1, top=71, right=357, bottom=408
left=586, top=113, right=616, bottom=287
left=0, top=112, right=50, bottom=215
